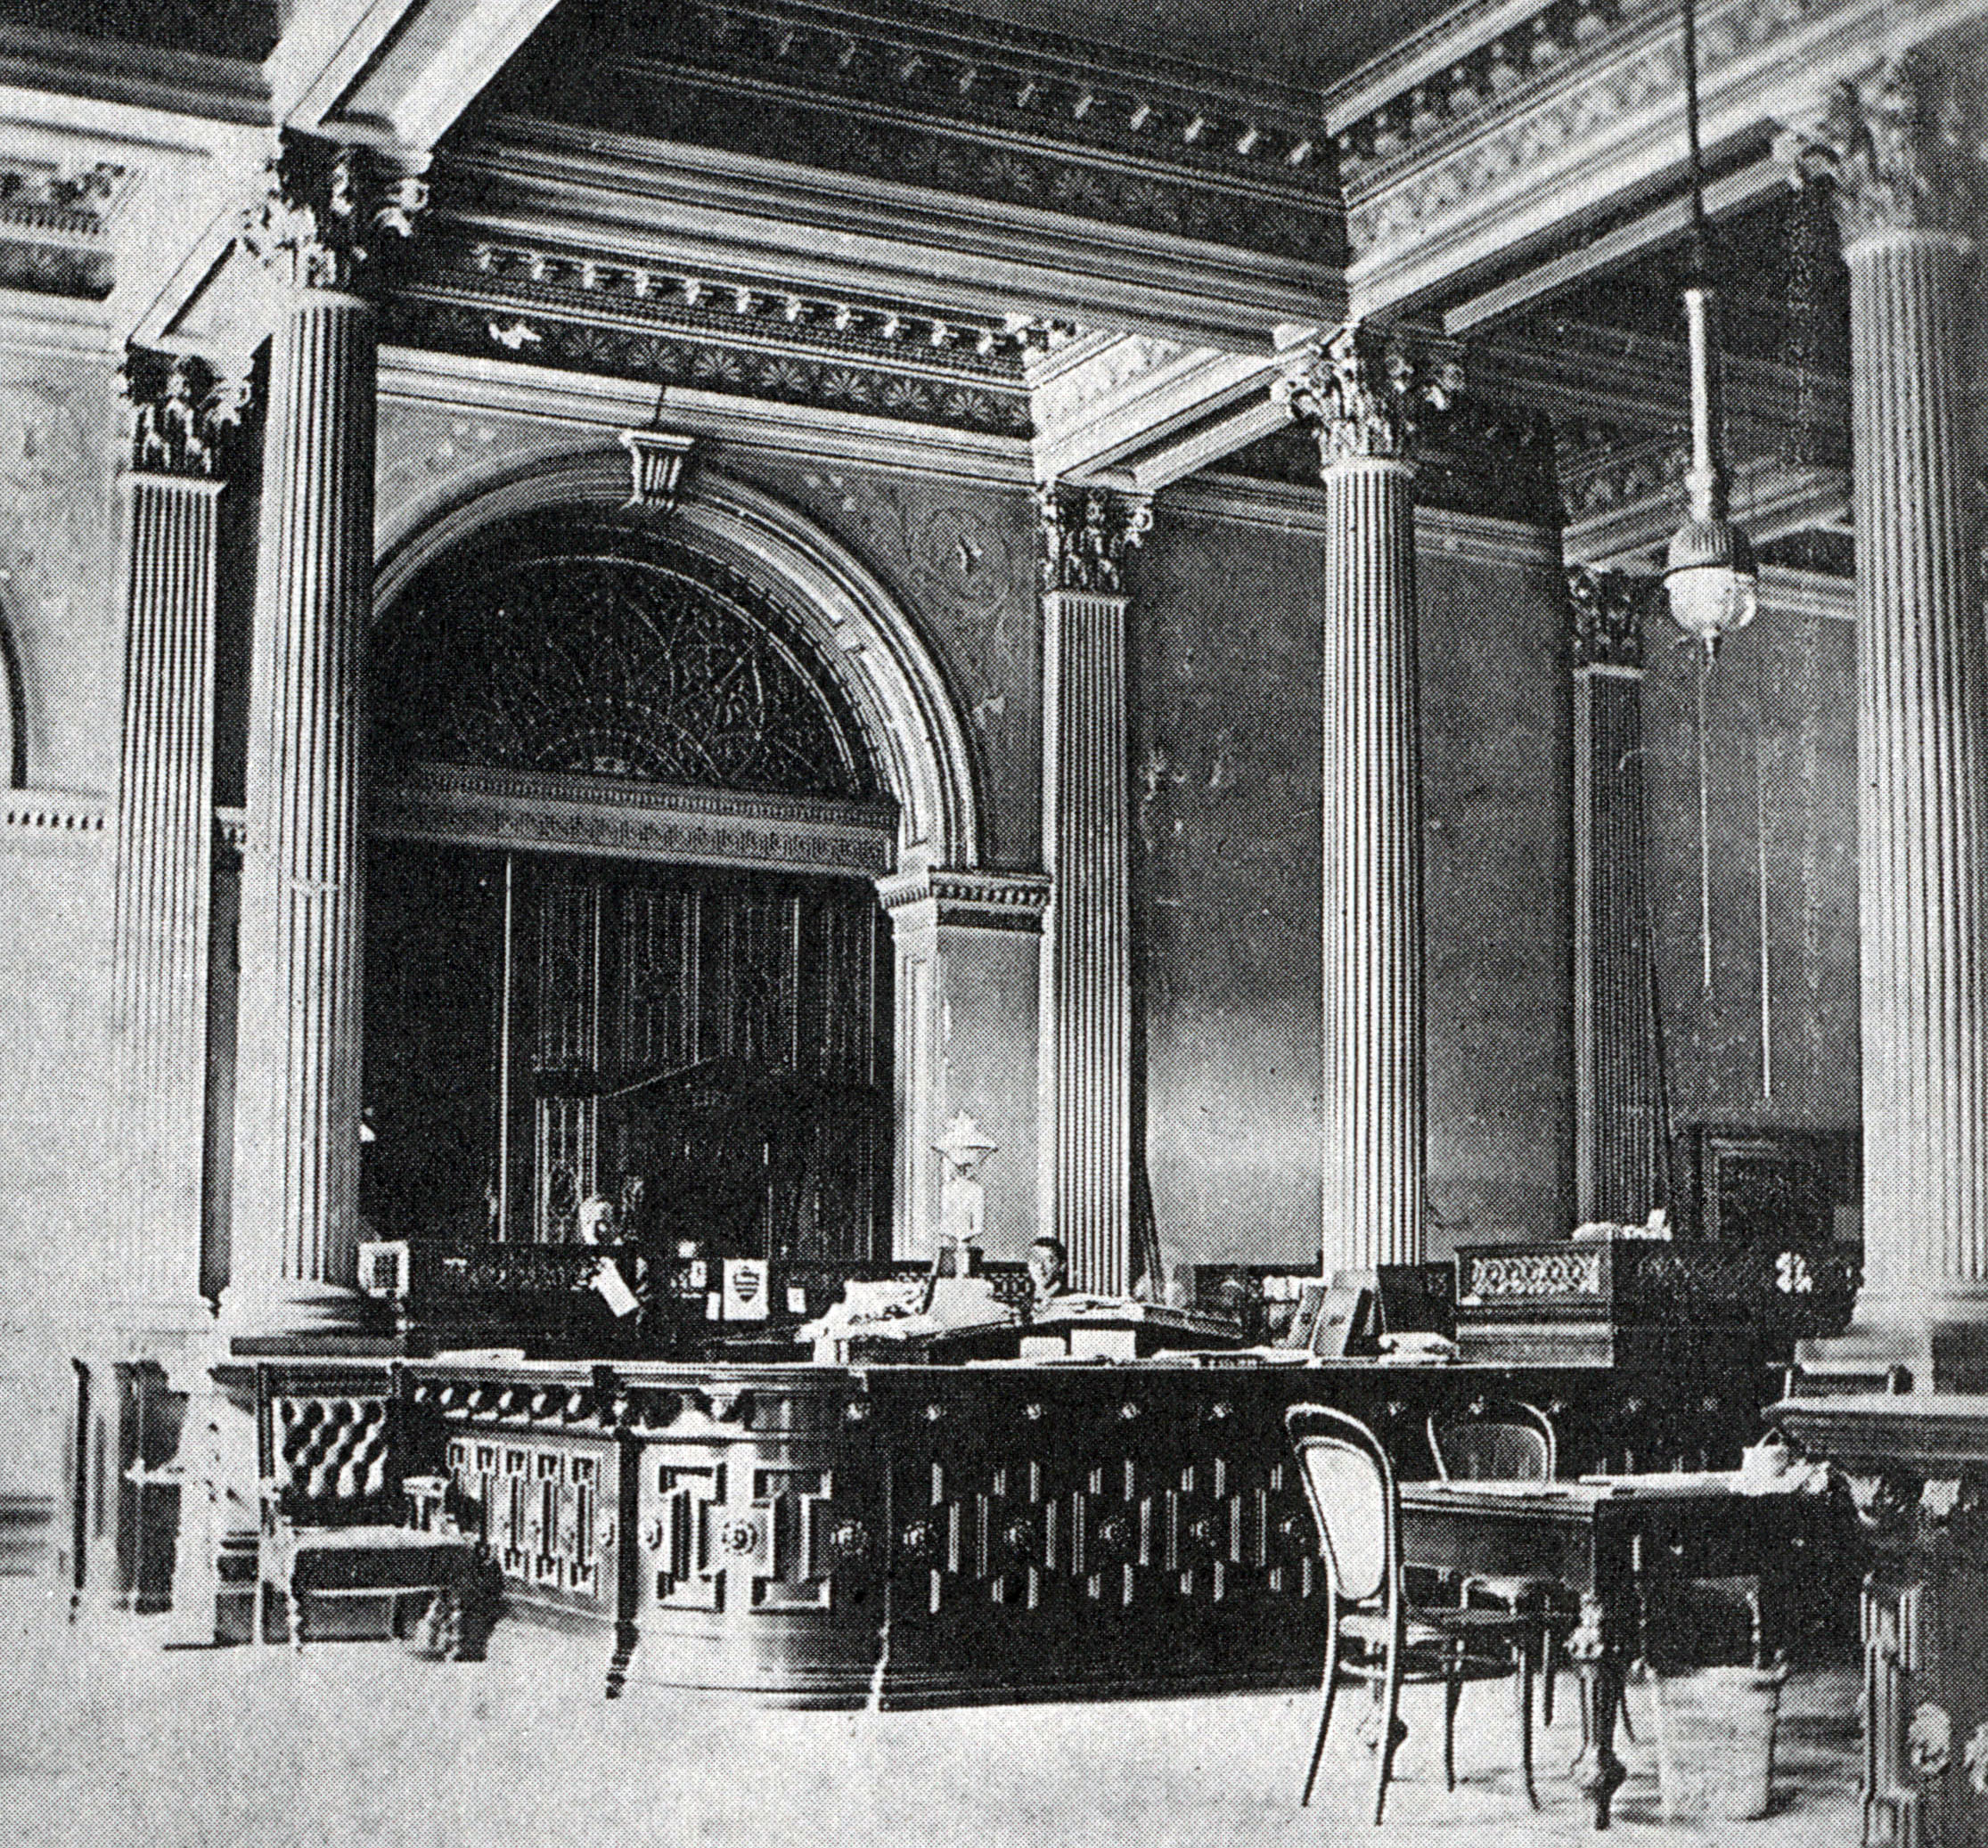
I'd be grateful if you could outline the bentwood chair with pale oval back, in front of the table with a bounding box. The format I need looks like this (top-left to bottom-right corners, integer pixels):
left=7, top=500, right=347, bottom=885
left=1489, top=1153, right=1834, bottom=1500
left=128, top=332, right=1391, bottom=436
left=1284, top=1405, right=1539, bottom=1822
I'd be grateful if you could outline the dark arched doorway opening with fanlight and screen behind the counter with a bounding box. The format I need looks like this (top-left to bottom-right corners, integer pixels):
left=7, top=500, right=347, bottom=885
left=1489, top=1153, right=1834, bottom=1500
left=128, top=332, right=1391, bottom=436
left=366, top=496, right=898, bottom=1260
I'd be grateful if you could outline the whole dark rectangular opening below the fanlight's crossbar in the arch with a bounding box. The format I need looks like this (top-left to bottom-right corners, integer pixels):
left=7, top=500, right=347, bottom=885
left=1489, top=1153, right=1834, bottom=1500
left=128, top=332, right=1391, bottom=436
left=366, top=843, right=890, bottom=1262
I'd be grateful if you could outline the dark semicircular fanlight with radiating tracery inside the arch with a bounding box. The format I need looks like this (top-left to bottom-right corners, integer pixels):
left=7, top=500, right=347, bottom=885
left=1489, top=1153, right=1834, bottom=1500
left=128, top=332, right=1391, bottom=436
left=370, top=519, right=879, bottom=801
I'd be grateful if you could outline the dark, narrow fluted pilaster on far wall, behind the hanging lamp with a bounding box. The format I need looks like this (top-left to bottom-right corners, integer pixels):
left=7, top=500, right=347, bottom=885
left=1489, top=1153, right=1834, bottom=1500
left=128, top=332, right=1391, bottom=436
left=1567, top=570, right=1664, bottom=1224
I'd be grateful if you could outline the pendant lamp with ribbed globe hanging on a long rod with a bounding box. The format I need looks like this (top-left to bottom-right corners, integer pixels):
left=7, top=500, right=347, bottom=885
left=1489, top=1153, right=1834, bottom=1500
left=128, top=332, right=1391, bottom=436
left=1664, top=0, right=1759, bottom=658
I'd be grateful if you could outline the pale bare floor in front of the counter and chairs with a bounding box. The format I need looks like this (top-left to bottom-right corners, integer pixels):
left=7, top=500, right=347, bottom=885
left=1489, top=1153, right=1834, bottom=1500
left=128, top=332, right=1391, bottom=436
left=0, top=1578, right=1859, bottom=1848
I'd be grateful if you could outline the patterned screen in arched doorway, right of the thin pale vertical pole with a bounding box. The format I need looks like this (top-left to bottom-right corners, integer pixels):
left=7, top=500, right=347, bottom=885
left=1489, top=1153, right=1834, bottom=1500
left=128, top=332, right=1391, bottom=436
left=509, top=861, right=890, bottom=1260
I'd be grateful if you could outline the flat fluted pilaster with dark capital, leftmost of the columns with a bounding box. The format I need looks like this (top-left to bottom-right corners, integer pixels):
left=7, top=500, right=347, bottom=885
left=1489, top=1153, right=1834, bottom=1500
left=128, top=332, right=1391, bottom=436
left=105, top=354, right=239, bottom=1329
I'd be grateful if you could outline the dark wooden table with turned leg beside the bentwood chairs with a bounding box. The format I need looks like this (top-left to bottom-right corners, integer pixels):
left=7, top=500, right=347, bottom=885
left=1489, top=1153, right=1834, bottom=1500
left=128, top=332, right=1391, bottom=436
left=1402, top=1473, right=1815, bottom=1828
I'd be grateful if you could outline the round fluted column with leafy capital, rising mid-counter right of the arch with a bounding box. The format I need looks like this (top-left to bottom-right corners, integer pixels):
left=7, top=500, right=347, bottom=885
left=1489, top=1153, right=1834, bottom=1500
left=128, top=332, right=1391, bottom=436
left=1282, top=328, right=1426, bottom=1276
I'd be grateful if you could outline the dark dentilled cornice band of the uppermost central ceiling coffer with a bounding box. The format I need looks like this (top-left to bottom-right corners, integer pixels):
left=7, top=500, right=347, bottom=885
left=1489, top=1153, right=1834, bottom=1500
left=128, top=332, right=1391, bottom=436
left=475, top=0, right=1344, bottom=266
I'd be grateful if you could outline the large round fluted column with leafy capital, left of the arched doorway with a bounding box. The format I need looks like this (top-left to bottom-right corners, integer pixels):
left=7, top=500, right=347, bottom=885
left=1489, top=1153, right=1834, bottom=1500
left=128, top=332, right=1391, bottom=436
left=225, top=139, right=420, bottom=1331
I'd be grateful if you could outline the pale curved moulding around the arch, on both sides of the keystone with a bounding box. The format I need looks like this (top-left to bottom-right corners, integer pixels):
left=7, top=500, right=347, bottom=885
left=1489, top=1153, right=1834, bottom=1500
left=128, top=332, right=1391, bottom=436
left=373, top=446, right=980, bottom=872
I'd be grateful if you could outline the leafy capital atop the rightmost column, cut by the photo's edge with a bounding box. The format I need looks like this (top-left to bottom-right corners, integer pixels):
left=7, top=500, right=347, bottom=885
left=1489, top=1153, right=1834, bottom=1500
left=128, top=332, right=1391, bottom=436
left=1779, top=50, right=1988, bottom=247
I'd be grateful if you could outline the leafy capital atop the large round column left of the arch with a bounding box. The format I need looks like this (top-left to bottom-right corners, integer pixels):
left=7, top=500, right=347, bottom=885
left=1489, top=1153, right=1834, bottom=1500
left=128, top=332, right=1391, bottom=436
left=241, top=135, right=428, bottom=288
